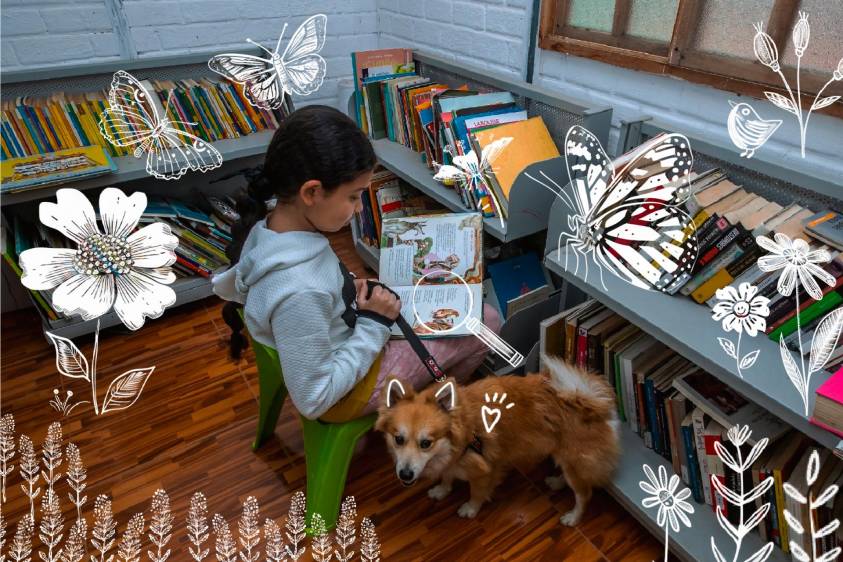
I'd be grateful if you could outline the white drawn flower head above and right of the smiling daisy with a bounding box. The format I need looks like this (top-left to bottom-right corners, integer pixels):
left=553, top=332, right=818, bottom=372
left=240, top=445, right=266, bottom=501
left=756, top=232, right=835, bottom=300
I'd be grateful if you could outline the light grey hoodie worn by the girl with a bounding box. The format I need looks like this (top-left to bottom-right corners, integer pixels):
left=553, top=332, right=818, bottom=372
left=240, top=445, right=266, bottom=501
left=212, top=220, right=390, bottom=419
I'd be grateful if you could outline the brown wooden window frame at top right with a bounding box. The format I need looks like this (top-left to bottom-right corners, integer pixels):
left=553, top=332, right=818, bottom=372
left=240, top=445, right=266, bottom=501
left=539, top=0, right=843, bottom=118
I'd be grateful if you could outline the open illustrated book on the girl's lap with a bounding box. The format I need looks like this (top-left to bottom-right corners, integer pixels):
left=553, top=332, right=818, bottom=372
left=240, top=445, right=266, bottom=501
left=379, top=213, right=483, bottom=337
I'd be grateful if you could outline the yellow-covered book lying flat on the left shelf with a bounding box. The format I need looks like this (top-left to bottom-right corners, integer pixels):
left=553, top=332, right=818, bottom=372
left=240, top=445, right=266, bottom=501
left=0, top=146, right=117, bottom=194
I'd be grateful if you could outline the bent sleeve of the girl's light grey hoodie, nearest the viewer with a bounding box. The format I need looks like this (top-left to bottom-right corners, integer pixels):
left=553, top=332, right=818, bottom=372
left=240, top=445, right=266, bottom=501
left=271, top=291, right=390, bottom=419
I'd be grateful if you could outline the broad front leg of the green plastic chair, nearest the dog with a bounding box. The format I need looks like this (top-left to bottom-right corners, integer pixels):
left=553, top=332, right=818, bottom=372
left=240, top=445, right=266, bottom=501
left=302, top=418, right=374, bottom=534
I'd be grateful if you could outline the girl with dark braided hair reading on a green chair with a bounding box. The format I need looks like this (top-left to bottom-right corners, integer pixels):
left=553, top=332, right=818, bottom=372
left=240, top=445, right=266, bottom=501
left=213, top=105, right=500, bottom=422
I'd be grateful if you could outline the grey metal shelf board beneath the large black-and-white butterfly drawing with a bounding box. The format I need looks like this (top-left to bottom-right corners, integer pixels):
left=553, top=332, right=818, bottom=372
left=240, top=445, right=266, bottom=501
left=545, top=250, right=840, bottom=449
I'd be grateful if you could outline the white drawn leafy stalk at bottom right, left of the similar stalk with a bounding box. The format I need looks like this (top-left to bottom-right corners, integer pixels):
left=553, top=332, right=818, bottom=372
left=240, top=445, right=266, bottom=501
left=711, top=425, right=774, bottom=562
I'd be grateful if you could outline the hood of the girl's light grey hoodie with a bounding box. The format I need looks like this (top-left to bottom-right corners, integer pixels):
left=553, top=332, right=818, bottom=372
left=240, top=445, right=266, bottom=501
left=211, top=219, right=329, bottom=303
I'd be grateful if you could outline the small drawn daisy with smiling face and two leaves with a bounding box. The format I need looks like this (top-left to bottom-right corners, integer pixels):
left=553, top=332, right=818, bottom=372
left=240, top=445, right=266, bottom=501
left=712, top=283, right=770, bottom=378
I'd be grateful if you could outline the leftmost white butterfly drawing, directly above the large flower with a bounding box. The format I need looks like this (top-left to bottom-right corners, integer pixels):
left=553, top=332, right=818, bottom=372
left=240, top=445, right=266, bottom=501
left=99, top=70, right=222, bottom=180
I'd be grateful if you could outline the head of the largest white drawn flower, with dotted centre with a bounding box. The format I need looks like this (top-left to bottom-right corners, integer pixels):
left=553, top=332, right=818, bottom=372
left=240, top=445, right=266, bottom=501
left=20, top=187, right=178, bottom=330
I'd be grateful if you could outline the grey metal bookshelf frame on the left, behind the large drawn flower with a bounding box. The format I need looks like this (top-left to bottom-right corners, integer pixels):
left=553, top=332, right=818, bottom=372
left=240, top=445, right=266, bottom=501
left=0, top=54, right=274, bottom=338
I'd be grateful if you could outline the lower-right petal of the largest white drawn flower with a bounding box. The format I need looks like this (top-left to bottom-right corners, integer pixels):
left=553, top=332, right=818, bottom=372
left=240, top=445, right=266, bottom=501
left=114, top=269, right=176, bottom=330
